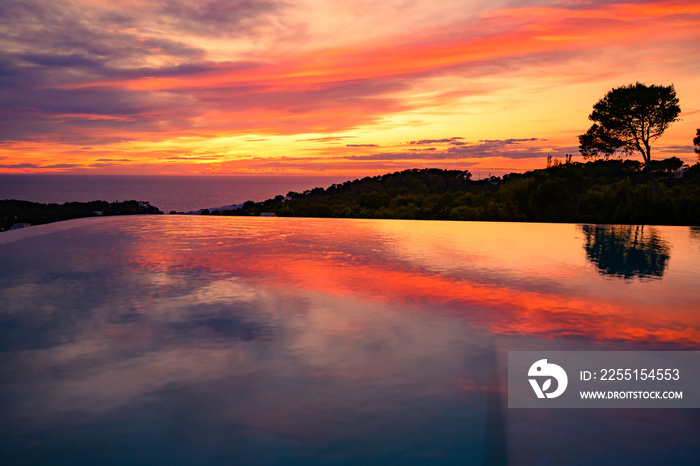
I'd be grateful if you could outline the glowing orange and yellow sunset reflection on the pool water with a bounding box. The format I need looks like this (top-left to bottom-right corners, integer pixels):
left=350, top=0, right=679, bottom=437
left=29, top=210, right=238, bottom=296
left=102, top=219, right=699, bottom=344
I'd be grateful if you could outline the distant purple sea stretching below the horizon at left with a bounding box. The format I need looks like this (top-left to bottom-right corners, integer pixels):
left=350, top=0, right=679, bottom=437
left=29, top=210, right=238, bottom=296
left=0, top=174, right=352, bottom=213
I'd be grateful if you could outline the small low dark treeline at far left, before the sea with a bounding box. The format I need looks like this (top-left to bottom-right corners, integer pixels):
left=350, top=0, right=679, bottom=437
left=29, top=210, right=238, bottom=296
left=0, top=199, right=163, bottom=231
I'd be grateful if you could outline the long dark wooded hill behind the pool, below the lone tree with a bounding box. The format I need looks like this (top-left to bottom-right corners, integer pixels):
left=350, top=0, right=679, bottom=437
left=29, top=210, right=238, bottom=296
left=212, top=157, right=700, bottom=225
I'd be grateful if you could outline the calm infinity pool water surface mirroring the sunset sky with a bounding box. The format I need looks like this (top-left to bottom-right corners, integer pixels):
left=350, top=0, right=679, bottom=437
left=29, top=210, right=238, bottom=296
left=0, top=216, right=700, bottom=465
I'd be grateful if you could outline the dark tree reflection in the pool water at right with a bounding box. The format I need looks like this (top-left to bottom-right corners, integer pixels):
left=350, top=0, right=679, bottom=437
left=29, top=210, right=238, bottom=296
left=581, top=225, right=671, bottom=278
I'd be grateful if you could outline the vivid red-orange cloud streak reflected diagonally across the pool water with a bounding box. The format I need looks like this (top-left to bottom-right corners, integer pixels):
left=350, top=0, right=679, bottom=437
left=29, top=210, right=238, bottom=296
left=231, top=257, right=700, bottom=344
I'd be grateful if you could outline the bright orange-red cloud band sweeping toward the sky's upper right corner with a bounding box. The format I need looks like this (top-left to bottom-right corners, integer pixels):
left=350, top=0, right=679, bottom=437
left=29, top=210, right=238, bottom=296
left=90, top=3, right=700, bottom=93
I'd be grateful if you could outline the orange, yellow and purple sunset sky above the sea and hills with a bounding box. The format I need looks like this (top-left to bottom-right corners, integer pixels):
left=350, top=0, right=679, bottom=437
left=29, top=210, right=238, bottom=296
left=0, top=0, right=700, bottom=177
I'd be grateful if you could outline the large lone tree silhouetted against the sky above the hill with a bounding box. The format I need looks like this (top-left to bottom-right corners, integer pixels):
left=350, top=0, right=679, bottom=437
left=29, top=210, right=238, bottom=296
left=579, top=83, right=681, bottom=192
